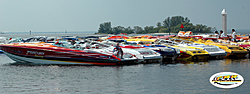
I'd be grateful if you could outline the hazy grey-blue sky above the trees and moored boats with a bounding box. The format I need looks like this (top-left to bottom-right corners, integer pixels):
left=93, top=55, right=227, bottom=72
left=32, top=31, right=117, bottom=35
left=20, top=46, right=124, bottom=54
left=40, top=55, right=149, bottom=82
left=0, top=0, right=250, bottom=31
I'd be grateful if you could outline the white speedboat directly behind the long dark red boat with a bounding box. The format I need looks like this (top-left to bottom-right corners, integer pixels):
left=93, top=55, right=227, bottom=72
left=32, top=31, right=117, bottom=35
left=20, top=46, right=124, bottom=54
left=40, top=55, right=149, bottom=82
left=53, top=40, right=144, bottom=64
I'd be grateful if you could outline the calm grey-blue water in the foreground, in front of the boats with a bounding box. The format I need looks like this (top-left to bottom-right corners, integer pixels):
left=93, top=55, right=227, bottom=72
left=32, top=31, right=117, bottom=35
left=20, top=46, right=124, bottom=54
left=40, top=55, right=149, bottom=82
left=0, top=54, right=250, bottom=94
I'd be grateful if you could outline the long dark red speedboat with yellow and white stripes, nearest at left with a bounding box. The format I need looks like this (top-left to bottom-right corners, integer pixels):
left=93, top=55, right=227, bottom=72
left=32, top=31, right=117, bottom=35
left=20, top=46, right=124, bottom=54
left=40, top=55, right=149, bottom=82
left=0, top=43, right=141, bottom=65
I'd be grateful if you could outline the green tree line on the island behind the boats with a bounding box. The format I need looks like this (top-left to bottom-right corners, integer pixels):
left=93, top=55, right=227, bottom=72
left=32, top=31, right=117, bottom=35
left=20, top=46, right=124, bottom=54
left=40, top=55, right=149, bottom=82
left=98, top=16, right=216, bottom=34
